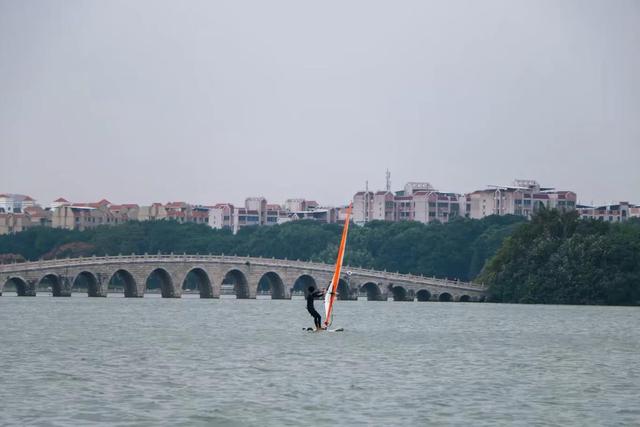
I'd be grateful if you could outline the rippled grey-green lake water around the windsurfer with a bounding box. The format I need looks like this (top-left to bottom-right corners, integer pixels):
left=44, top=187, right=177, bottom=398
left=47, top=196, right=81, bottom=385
left=0, top=294, right=640, bottom=426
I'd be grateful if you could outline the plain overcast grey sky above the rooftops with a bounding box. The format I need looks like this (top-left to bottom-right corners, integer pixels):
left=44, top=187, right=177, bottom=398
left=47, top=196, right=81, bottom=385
left=0, top=0, right=640, bottom=205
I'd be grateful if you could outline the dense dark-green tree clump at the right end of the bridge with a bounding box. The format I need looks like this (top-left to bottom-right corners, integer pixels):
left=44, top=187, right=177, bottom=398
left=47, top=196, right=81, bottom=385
left=479, top=210, right=640, bottom=305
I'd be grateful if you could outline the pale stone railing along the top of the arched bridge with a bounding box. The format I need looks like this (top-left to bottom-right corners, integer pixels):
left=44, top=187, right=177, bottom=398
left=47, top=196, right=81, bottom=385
left=0, top=254, right=485, bottom=291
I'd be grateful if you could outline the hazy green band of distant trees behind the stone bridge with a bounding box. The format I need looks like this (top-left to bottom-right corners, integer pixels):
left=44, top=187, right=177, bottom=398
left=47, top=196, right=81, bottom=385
left=0, top=216, right=523, bottom=280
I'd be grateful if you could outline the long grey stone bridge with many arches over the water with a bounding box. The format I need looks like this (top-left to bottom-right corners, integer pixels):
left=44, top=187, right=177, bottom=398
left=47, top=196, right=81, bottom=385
left=0, top=254, right=486, bottom=301
